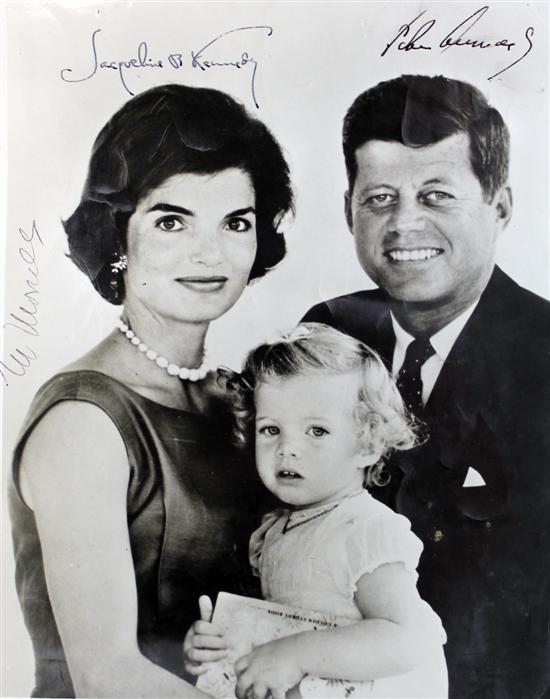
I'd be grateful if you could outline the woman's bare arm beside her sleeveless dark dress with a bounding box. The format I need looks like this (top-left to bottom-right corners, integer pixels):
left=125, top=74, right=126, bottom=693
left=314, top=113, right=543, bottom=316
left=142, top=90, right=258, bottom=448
left=21, top=401, right=206, bottom=697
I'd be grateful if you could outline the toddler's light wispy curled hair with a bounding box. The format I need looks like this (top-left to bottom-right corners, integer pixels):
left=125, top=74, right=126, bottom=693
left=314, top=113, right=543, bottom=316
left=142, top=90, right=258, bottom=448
left=229, top=323, right=418, bottom=486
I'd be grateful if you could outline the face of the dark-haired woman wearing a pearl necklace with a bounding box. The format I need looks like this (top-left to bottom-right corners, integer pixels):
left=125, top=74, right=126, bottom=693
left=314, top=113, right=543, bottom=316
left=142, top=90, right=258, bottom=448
left=124, top=168, right=256, bottom=323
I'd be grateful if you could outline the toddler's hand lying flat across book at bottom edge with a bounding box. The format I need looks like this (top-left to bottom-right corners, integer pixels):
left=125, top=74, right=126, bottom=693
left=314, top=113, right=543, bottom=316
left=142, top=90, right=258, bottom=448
left=235, top=636, right=305, bottom=699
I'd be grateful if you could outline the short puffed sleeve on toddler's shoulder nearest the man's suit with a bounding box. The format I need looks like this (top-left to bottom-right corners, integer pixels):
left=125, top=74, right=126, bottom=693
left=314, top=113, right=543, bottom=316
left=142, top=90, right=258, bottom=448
left=345, top=512, right=423, bottom=594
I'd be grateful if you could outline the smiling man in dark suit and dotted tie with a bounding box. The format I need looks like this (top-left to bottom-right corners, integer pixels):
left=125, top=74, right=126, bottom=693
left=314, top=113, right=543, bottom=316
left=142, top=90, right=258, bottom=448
left=304, top=76, right=550, bottom=699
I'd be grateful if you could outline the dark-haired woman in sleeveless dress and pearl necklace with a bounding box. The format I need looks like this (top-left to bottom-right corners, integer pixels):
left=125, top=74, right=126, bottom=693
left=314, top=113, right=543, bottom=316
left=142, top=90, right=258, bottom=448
left=10, top=85, right=292, bottom=697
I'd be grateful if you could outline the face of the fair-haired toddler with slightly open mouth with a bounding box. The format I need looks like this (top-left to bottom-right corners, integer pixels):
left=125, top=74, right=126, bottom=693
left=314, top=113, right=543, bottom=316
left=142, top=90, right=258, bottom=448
left=255, top=371, right=367, bottom=507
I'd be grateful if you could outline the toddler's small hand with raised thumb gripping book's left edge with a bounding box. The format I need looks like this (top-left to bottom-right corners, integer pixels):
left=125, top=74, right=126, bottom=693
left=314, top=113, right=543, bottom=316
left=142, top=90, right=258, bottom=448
left=183, top=595, right=228, bottom=677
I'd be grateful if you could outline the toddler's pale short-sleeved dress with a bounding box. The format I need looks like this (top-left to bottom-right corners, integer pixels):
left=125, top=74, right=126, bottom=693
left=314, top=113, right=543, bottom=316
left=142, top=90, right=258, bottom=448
left=250, top=490, right=447, bottom=699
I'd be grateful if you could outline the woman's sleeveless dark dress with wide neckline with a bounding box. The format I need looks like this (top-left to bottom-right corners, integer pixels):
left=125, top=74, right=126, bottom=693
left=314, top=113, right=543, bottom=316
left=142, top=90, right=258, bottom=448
left=9, top=371, right=259, bottom=697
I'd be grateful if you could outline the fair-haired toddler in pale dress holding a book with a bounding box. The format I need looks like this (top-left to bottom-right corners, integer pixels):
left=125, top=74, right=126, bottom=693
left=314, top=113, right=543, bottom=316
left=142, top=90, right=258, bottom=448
left=186, top=323, right=447, bottom=699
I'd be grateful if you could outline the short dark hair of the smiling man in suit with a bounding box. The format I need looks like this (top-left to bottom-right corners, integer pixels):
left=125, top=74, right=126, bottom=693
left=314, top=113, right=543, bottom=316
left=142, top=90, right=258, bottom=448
left=343, top=75, right=510, bottom=201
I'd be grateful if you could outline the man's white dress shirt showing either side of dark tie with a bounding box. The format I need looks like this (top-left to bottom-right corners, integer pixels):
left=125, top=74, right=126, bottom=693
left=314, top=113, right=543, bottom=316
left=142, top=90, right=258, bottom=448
left=390, top=299, right=479, bottom=405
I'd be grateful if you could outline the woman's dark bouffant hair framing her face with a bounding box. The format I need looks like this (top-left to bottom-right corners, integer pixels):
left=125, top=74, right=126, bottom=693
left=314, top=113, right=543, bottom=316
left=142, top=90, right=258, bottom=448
left=64, top=85, right=293, bottom=304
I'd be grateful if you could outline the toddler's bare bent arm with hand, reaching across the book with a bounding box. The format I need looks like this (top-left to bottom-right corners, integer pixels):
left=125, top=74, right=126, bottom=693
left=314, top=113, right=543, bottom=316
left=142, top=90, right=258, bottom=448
left=235, top=563, right=441, bottom=697
